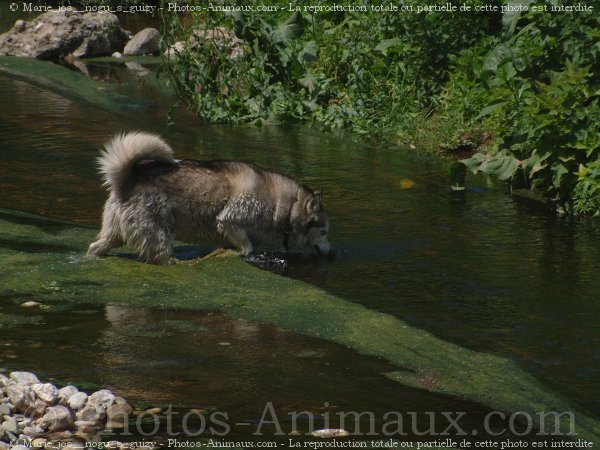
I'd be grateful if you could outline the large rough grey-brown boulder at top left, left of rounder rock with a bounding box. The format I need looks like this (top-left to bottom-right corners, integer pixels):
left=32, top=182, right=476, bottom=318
left=0, top=11, right=129, bottom=59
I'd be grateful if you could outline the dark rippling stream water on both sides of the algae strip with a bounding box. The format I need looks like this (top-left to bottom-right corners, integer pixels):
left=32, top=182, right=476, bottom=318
left=0, top=64, right=600, bottom=442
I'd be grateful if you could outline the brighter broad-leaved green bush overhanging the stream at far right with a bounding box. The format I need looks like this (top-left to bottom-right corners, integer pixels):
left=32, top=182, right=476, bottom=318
left=454, top=5, right=600, bottom=214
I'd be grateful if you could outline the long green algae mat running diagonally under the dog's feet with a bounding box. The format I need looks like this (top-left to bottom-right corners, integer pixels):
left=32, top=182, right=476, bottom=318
left=0, top=210, right=600, bottom=442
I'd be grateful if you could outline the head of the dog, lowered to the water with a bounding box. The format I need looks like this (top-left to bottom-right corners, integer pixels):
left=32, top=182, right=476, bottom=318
left=291, top=188, right=335, bottom=257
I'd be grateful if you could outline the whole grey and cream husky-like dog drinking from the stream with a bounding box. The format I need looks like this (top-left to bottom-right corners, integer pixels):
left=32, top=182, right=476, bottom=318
left=87, top=132, right=334, bottom=264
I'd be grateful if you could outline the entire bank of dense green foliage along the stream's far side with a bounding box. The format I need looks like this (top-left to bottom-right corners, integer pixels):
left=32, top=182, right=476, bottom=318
left=158, top=0, right=600, bottom=214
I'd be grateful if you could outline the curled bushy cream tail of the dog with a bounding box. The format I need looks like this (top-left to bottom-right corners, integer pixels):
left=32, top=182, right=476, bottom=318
left=98, top=131, right=175, bottom=192
